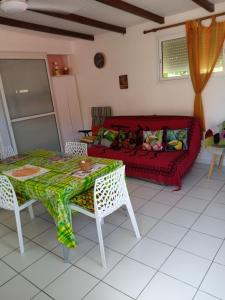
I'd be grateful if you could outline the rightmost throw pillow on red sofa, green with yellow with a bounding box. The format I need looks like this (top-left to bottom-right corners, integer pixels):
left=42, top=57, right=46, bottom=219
left=166, top=128, right=188, bottom=151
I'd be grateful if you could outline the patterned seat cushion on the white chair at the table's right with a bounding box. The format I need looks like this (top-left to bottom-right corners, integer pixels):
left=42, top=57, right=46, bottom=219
left=70, top=188, right=94, bottom=212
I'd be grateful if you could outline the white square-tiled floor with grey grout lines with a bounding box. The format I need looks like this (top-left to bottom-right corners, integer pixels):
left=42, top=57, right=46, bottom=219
left=0, top=163, right=225, bottom=300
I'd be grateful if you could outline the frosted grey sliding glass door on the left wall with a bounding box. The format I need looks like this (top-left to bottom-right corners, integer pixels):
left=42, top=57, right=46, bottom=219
left=0, top=59, right=60, bottom=153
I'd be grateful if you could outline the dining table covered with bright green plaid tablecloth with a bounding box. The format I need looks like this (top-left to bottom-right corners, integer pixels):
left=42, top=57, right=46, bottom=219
left=0, top=149, right=123, bottom=249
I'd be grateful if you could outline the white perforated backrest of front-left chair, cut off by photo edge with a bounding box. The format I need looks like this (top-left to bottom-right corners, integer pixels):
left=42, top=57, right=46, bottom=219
left=0, top=175, right=18, bottom=210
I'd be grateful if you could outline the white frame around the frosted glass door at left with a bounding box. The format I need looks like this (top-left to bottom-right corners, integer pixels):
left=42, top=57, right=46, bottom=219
left=0, top=52, right=63, bottom=153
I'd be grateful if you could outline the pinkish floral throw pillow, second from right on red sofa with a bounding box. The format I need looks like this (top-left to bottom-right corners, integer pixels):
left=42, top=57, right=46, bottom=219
left=142, top=130, right=163, bottom=151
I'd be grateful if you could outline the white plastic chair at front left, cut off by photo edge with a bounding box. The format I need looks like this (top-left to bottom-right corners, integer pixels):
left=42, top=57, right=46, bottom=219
left=0, top=175, right=36, bottom=254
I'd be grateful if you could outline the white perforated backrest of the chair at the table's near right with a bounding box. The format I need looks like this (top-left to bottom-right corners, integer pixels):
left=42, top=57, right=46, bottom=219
left=94, top=166, right=129, bottom=217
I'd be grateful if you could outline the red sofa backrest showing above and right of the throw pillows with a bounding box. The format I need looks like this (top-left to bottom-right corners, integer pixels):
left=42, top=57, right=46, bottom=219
left=103, top=115, right=202, bottom=152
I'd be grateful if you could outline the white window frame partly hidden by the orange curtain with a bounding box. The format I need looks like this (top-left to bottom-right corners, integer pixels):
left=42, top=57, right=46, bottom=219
left=158, top=32, right=225, bottom=81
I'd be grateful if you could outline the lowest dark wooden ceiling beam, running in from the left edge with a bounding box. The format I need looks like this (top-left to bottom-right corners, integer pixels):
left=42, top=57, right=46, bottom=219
left=0, top=17, right=94, bottom=41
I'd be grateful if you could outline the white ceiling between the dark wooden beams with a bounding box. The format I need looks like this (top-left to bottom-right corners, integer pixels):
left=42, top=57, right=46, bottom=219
left=0, top=0, right=225, bottom=35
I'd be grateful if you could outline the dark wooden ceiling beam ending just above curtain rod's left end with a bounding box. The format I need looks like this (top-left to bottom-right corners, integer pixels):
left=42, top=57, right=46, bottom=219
left=95, top=0, right=165, bottom=24
